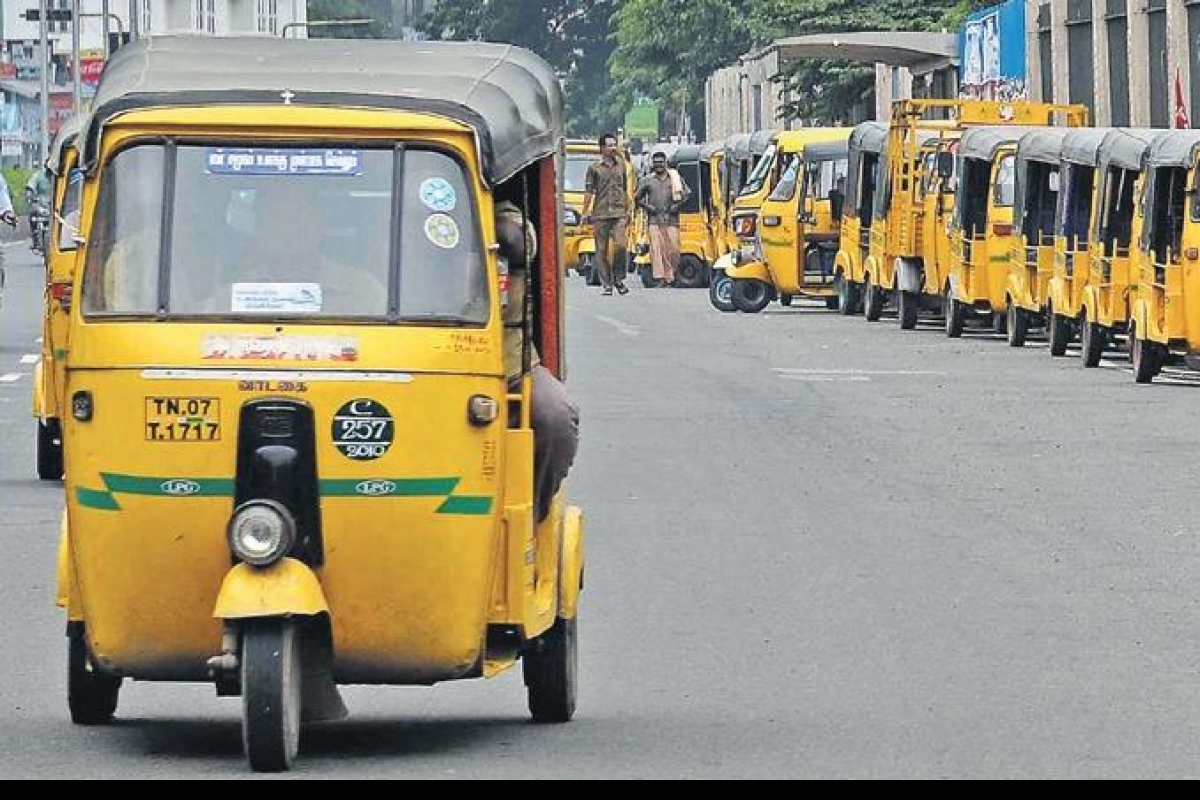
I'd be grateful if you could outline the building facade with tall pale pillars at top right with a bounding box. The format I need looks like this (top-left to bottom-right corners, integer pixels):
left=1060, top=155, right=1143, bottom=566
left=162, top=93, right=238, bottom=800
left=1026, top=0, right=1200, bottom=127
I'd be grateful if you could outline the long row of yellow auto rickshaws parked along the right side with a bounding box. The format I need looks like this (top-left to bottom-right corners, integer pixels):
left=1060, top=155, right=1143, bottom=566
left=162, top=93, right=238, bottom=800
left=714, top=101, right=1200, bottom=383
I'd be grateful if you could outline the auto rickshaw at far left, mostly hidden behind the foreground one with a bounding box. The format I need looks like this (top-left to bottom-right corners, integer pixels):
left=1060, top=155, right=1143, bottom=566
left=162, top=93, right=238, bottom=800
left=34, top=118, right=83, bottom=481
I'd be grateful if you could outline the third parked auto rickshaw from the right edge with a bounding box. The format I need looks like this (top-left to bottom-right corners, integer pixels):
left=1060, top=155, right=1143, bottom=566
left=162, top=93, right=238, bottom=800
left=1045, top=128, right=1109, bottom=355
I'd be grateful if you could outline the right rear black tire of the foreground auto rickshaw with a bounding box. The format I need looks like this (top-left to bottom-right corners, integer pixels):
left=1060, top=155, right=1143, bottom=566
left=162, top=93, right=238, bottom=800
left=522, top=618, right=580, bottom=724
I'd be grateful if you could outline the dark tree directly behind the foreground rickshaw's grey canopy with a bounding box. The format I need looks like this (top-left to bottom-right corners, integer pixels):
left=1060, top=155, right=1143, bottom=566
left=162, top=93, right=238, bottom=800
left=419, top=0, right=620, bottom=136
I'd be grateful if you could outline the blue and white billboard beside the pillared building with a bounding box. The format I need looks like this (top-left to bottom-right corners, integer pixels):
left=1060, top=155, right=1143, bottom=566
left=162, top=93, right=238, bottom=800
left=959, top=0, right=1027, bottom=100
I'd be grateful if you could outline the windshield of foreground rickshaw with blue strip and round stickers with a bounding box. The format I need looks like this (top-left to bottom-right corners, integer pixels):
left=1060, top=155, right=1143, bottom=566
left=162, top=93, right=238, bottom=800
left=83, top=143, right=490, bottom=325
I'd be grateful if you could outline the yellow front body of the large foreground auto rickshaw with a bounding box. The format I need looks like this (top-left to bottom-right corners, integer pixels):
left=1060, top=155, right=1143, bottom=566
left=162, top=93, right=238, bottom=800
left=60, top=107, right=582, bottom=684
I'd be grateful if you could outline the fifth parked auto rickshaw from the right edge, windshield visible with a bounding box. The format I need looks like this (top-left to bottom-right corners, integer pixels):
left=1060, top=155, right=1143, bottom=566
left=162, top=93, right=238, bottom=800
left=946, top=126, right=1031, bottom=338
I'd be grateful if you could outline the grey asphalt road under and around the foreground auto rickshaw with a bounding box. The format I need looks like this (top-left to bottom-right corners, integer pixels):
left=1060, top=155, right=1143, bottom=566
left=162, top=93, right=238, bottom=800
left=7, top=247, right=1200, bottom=778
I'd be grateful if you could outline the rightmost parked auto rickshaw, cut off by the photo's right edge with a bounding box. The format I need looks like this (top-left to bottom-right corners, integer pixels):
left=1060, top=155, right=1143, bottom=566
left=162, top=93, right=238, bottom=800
left=1114, top=131, right=1200, bottom=384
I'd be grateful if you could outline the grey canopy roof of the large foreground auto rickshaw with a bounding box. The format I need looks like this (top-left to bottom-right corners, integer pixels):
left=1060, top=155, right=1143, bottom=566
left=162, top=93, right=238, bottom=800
left=83, top=36, right=563, bottom=185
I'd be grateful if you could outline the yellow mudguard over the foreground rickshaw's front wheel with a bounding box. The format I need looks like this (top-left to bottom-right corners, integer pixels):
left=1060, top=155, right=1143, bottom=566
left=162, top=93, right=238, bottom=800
left=212, top=559, right=329, bottom=620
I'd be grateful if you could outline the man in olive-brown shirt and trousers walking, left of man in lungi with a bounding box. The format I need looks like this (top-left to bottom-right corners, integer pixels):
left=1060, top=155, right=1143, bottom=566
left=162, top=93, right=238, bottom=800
left=583, top=133, right=630, bottom=295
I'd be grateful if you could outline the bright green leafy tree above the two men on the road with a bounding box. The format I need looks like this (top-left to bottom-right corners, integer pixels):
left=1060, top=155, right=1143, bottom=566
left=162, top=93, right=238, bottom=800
left=608, top=0, right=752, bottom=137
